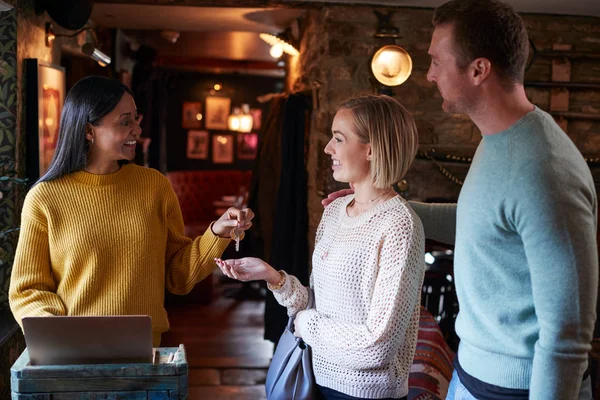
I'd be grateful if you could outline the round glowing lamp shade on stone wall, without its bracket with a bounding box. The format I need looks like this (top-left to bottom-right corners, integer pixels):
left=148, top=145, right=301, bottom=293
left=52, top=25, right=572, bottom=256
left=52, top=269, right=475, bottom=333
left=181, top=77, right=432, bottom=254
left=371, top=45, right=412, bottom=86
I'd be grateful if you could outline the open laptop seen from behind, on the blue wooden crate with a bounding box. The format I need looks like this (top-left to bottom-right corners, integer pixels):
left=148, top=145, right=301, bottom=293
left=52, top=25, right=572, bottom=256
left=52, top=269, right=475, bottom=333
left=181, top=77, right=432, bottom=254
left=23, top=315, right=154, bottom=365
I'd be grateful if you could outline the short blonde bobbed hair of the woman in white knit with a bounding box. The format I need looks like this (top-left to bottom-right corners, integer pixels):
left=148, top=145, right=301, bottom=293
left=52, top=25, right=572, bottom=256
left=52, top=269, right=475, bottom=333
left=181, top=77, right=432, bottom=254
left=336, top=95, right=419, bottom=189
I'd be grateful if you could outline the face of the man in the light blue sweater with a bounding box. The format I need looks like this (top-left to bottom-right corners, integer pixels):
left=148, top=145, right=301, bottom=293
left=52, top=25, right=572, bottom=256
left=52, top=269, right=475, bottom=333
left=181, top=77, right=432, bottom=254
left=427, top=24, right=476, bottom=114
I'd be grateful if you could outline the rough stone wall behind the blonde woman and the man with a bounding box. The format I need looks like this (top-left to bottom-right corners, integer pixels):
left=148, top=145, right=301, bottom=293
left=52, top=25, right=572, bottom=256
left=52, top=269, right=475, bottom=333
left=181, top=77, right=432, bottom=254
left=288, top=6, right=600, bottom=250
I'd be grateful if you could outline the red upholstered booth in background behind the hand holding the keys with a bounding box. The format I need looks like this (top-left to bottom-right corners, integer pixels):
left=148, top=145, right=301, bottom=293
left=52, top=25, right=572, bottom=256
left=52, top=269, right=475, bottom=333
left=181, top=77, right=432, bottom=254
left=167, top=170, right=252, bottom=304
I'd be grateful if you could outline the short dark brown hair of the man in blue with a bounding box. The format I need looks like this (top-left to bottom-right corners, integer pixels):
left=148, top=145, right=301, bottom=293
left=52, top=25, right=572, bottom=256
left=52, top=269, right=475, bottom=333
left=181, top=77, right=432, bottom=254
left=433, top=0, right=529, bottom=86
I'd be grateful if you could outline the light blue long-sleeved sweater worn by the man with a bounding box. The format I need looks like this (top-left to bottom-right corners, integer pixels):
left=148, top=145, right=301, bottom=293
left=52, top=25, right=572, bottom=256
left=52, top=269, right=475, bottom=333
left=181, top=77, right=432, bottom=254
left=411, top=107, right=598, bottom=400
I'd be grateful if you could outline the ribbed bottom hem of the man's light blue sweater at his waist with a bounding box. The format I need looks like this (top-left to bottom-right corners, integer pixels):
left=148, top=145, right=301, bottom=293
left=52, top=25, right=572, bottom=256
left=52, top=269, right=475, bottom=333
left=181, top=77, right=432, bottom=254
left=458, top=340, right=533, bottom=389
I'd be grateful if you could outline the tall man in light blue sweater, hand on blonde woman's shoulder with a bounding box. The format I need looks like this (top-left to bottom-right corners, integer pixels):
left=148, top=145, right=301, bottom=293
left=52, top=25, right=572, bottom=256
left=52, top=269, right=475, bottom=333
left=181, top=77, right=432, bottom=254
left=326, top=0, right=598, bottom=400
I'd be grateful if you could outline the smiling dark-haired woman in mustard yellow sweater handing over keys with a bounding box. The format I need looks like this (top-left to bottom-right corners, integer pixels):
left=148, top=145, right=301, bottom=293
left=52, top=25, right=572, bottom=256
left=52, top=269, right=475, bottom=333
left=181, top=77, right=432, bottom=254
left=9, top=76, right=254, bottom=346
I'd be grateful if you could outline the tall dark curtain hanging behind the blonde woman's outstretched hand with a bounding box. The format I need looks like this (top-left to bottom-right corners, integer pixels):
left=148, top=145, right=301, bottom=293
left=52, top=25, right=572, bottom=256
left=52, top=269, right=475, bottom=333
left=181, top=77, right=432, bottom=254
left=248, top=94, right=310, bottom=343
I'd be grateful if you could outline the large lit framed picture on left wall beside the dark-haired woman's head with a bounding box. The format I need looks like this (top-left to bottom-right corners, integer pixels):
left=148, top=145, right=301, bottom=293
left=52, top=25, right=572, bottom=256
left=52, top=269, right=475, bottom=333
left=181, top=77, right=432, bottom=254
left=25, top=58, right=65, bottom=182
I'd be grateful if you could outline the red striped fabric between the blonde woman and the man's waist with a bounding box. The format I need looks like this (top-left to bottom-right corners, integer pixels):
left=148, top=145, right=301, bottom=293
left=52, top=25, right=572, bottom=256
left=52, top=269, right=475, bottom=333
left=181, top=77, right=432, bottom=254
left=408, top=306, right=454, bottom=400
